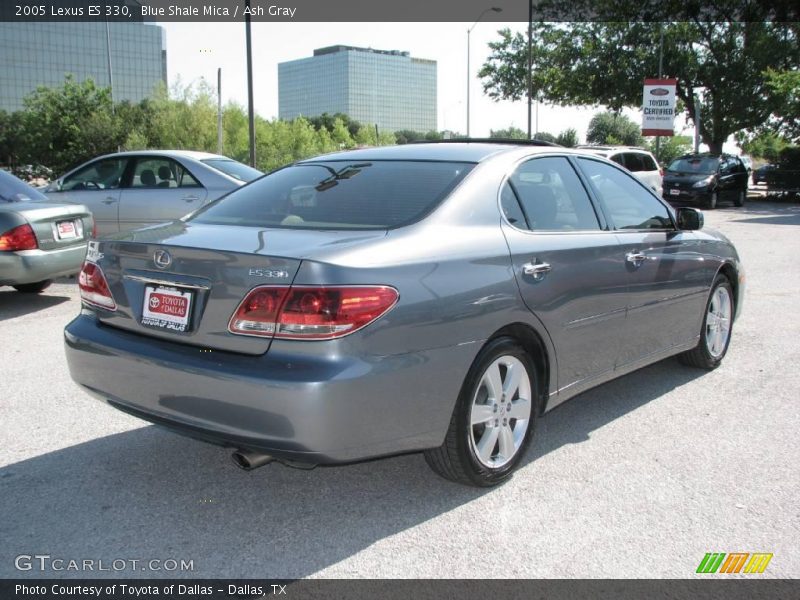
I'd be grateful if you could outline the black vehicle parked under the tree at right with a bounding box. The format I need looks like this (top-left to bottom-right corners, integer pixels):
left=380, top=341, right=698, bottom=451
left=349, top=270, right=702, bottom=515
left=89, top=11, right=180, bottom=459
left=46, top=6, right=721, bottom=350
left=664, top=153, right=748, bottom=208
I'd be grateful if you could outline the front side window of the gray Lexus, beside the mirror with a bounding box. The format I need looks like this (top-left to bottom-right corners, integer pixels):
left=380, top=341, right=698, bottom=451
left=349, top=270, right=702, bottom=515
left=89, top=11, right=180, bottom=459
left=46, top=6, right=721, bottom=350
left=578, top=158, right=673, bottom=229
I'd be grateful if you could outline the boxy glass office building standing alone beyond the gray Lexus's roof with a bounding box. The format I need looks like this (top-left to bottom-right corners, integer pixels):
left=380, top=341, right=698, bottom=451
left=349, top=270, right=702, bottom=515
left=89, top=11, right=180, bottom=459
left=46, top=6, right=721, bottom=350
left=278, top=46, right=437, bottom=132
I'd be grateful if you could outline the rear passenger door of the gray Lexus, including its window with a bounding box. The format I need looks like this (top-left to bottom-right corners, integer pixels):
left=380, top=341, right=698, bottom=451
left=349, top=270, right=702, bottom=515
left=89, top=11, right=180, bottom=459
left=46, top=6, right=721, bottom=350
left=501, top=156, right=627, bottom=390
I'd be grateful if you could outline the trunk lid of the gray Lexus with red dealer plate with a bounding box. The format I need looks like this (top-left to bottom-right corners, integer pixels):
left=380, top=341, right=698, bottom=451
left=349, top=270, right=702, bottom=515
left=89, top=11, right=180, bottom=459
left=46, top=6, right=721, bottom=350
left=89, top=221, right=385, bottom=354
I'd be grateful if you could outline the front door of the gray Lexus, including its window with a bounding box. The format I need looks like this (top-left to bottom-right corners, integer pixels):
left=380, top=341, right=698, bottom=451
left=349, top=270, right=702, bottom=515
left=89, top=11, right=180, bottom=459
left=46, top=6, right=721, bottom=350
left=577, top=157, right=714, bottom=368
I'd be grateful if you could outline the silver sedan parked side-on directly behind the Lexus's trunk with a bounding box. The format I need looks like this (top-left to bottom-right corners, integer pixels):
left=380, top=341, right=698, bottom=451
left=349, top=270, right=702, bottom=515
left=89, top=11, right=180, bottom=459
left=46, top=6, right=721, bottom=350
left=45, top=150, right=263, bottom=235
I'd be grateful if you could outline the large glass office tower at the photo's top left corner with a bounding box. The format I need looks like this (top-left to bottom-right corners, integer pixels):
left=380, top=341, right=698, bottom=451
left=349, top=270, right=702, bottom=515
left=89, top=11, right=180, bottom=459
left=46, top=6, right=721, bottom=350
left=0, top=22, right=167, bottom=112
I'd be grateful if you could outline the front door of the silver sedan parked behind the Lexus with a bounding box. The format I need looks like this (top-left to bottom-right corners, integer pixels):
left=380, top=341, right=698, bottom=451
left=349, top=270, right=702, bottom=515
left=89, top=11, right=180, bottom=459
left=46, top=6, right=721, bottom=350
left=46, top=157, right=128, bottom=235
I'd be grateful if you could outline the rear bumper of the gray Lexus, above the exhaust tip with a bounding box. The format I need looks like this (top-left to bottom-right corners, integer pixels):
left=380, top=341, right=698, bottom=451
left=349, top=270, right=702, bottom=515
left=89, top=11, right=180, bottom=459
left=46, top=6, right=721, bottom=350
left=64, top=312, right=479, bottom=464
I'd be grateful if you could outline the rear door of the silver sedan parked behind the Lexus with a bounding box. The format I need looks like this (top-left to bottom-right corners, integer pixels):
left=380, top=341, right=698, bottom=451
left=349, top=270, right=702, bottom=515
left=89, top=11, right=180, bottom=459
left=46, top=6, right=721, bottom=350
left=119, top=155, right=208, bottom=231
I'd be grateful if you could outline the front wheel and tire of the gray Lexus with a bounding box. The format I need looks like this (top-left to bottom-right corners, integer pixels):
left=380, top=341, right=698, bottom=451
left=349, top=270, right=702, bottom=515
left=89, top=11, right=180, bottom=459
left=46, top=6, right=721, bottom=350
left=678, top=275, right=735, bottom=370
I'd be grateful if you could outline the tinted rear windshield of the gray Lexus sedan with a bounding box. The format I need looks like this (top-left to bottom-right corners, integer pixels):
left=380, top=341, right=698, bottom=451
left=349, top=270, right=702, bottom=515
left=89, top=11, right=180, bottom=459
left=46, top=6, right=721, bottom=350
left=190, top=161, right=475, bottom=229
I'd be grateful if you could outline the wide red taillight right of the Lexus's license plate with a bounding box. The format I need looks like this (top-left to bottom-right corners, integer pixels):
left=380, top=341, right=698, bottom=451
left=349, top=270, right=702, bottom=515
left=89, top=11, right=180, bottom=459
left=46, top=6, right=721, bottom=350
left=228, top=286, right=398, bottom=340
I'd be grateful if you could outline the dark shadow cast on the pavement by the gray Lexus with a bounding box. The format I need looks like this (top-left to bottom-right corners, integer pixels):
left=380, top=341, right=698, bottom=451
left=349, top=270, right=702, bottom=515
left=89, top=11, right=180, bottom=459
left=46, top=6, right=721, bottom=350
left=0, top=360, right=703, bottom=578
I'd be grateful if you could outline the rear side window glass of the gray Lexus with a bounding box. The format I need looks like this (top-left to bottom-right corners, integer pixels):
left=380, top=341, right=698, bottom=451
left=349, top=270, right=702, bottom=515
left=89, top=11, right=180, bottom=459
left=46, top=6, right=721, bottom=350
left=501, top=156, right=600, bottom=231
